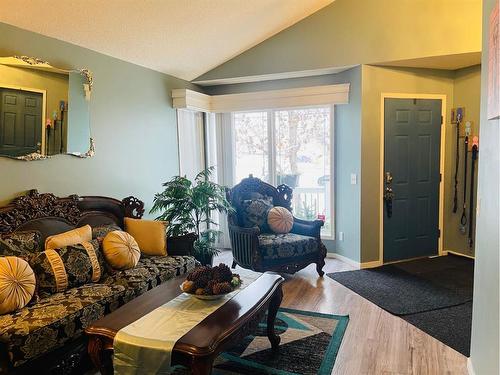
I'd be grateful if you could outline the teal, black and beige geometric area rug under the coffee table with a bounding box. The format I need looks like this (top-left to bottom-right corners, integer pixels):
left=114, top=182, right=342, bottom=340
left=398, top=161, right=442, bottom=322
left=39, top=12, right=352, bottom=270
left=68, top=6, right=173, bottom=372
left=175, top=308, right=349, bottom=375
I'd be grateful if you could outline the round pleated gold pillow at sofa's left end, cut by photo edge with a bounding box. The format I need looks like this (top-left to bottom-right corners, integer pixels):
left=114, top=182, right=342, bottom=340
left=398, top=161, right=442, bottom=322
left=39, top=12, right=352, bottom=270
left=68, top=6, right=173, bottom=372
left=0, top=257, right=36, bottom=315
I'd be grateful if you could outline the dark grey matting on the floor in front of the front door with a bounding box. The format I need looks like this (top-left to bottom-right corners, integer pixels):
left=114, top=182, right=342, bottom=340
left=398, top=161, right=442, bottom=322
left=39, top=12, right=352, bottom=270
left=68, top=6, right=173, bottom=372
left=328, top=255, right=474, bottom=356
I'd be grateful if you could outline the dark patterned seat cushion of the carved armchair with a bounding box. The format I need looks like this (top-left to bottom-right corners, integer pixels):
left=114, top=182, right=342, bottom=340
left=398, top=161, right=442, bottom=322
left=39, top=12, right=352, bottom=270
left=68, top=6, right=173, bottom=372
left=259, top=233, right=318, bottom=261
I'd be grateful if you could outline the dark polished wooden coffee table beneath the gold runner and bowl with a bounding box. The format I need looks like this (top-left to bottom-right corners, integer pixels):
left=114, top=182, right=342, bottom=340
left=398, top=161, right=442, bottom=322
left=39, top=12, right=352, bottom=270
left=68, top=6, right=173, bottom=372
left=85, top=272, right=284, bottom=374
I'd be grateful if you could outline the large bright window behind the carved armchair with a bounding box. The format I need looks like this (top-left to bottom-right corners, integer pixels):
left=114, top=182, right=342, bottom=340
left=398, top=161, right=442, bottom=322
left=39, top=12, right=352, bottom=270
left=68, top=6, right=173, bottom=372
left=231, top=106, right=334, bottom=237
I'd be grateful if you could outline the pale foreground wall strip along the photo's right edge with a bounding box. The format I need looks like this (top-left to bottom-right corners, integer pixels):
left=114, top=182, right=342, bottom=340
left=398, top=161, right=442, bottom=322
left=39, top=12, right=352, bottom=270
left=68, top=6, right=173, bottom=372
left=470, top=0, right=500, bottom=375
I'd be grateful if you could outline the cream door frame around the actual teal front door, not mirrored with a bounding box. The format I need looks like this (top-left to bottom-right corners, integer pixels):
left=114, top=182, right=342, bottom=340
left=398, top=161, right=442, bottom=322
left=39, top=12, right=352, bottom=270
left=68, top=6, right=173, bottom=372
left=378, top=92, right=447, bottom=264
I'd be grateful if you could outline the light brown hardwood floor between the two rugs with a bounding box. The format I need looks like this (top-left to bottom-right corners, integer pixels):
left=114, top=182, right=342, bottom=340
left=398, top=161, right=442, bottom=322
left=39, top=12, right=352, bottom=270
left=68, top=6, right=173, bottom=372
left=214, top=251, right=467, bottom=375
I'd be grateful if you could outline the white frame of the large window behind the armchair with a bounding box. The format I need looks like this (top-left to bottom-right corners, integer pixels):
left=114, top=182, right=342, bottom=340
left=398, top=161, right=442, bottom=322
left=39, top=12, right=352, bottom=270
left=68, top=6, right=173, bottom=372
left=230, top=104, right=337, bottom=241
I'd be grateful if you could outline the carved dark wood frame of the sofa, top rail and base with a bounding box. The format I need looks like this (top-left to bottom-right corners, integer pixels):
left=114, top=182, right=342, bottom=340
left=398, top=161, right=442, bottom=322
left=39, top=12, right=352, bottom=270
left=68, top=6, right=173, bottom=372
left=0, top=190, right=144, bottom=374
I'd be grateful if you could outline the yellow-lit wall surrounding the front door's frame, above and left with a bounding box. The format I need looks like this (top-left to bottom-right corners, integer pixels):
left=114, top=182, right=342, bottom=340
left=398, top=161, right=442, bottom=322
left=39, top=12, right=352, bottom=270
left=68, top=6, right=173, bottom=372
left=361, top=65, right=454, bottom=262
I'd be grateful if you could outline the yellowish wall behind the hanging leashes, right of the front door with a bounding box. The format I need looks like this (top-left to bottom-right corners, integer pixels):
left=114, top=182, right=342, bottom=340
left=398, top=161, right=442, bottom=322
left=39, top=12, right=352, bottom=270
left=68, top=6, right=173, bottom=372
left=443, top=65, right=481, bottom=256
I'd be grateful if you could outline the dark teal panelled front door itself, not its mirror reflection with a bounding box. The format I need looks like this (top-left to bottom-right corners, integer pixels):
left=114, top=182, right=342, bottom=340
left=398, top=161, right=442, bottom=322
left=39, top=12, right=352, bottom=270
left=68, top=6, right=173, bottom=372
left=383, top=99, right=442, bottom=262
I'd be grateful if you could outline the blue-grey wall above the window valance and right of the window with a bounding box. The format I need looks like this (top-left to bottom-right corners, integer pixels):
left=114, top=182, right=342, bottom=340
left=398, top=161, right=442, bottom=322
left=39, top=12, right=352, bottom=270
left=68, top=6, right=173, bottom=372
left=205, top=66, right=361, bottom=262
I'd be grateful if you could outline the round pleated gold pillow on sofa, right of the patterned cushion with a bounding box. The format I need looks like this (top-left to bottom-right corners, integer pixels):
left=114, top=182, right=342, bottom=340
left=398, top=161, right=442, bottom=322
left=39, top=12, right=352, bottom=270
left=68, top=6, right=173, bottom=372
left=102, top=230, right=141, bottom=270
